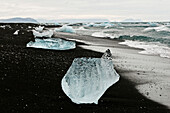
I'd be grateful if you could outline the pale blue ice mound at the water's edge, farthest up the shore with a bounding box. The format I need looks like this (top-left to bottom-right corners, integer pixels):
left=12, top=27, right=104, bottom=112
left=54, top=25, right=75, bottom=33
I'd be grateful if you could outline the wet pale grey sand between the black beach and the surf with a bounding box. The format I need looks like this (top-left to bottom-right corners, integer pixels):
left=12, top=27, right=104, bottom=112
left=54, top=33, right=170, bottom=109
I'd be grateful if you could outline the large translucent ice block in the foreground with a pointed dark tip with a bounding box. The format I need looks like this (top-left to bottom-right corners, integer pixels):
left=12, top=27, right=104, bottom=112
left=61, top=50, right=120, bottom=104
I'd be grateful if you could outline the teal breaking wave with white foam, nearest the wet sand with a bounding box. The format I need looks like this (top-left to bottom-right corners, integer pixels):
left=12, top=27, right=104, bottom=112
left=92, top=32, right=170, bottom=58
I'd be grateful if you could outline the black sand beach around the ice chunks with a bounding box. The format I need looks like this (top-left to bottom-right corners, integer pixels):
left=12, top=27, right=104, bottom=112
left=0, top=24, right=170, bottom=113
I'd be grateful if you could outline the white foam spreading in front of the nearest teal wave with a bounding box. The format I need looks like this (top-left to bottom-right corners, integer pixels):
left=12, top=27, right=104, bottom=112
left=119, top=40, right=170, bottom=58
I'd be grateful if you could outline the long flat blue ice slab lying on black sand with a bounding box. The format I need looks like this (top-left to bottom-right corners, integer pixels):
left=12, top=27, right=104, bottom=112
left=26, top=38, right=76, bottom=50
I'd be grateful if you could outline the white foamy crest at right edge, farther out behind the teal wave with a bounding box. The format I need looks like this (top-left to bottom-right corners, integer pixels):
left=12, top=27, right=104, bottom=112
left=143, top=25, right=170, bottom=32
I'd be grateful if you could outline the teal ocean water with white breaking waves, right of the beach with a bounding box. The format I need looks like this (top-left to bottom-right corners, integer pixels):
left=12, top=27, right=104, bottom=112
left=75, top=23, right=170, bottom=58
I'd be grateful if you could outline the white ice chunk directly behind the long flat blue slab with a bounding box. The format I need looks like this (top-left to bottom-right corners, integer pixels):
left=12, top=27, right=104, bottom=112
left=32, top=30, right=53, bottom=38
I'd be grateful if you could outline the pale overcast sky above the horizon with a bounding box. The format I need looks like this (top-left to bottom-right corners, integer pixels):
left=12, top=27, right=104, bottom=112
left=0, top=0, right=170, bottom=21
